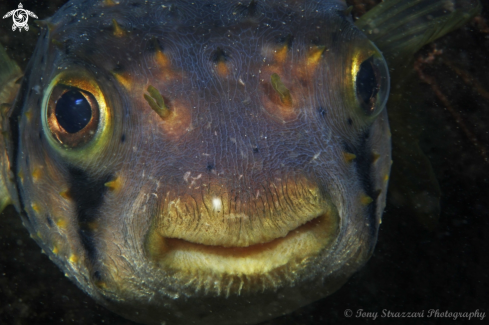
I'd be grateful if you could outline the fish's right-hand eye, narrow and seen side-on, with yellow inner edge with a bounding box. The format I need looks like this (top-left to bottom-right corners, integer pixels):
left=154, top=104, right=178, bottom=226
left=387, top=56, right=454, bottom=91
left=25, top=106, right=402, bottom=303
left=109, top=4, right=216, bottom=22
left=352, top=42, right=389, bottom=117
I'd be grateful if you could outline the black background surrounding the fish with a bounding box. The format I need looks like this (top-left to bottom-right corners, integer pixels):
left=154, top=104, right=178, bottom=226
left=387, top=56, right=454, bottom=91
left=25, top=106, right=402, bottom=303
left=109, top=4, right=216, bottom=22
left=0, top=0, right=489, bottom=325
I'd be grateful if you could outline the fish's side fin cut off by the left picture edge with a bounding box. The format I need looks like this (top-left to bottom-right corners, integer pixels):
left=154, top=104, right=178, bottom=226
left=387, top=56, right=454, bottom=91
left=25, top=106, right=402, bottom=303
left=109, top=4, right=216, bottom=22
left=0, top=46, right=22, bottom=212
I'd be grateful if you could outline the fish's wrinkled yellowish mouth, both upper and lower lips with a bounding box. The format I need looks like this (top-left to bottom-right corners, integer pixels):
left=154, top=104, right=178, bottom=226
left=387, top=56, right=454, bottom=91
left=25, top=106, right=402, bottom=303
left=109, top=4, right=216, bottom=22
left=146, top=176, right=339, bottom=276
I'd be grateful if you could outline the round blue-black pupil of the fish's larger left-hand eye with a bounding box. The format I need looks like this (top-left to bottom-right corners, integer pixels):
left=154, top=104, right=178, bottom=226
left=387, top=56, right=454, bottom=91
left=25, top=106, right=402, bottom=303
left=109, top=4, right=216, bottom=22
left=55, top=89, right=92, bottom=133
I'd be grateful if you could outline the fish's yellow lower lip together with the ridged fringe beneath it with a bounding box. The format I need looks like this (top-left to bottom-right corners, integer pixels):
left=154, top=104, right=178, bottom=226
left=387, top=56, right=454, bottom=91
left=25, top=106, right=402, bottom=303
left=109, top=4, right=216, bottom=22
left=147, top=213, right=339, bottom=297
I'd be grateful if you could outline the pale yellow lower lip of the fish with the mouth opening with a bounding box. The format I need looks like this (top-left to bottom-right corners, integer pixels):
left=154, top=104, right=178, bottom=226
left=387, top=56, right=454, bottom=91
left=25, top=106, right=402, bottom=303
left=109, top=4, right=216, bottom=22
left=146, top=211, right=339, bottom=278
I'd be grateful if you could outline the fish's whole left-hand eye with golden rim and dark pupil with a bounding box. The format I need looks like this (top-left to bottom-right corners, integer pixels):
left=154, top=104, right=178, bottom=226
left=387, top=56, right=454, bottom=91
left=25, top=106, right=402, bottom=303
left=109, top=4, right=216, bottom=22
left=42, top=71, right=110, bottom=156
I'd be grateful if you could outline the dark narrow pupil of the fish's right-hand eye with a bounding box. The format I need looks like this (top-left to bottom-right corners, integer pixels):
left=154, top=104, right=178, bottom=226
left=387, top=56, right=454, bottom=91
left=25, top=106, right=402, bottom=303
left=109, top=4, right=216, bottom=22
left=356, top=58, right=379, bottom=109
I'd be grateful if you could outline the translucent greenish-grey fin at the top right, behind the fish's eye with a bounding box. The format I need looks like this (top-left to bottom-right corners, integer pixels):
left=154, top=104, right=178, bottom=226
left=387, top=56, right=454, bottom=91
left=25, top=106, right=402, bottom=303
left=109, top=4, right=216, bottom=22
left=355, top=0, right=481, bottom=67
